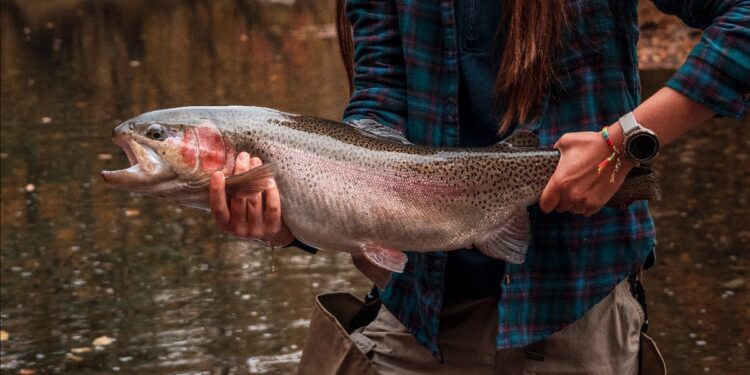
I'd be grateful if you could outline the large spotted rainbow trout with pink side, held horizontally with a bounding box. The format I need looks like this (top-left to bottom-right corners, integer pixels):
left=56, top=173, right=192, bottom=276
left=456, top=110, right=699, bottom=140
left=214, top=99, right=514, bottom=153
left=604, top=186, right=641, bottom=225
left=102, top=106, right=659, bottom=272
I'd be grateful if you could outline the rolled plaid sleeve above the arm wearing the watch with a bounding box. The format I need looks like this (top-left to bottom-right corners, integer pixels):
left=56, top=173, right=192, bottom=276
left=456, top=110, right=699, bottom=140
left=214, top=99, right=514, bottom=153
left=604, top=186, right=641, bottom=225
left=653, top=0, right=750, bottom=118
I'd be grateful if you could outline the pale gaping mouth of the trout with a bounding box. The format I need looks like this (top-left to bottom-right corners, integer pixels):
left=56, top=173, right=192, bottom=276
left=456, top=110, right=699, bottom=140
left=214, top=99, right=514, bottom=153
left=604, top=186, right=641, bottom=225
left=101, top=137, right=176, bottom=191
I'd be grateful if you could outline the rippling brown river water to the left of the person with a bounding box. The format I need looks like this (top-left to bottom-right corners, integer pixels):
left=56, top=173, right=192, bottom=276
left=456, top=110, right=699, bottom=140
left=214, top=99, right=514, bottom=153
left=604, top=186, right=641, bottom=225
left=0, top=1, right=367, bottom=373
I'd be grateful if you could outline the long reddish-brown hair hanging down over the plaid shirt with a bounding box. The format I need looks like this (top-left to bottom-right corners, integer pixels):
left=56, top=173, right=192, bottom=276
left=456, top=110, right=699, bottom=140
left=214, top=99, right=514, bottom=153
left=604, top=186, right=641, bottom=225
left=336, top=0, right=568, bottom=132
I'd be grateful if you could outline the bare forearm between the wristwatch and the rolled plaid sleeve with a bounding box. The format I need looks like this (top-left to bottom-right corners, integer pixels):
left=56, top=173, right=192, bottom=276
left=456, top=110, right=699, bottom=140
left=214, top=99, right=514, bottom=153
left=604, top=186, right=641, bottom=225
left=609, top=87, right=715, bottom=153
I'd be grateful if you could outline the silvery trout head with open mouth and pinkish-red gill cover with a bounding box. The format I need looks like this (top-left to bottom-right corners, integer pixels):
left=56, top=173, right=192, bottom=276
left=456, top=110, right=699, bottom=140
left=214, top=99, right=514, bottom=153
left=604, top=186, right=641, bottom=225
left=101, top=114, right=234, bottom=204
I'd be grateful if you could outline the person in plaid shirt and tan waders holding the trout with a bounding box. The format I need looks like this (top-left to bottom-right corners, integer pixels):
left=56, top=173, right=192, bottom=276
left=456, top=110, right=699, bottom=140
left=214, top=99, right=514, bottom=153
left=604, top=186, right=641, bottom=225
left=211, top=0, right=750, bottom=374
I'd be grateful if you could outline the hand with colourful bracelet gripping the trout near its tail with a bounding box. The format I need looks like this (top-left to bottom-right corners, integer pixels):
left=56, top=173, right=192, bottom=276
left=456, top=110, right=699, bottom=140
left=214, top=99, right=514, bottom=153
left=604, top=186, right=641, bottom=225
left=539, top=123, right=634, bottom=217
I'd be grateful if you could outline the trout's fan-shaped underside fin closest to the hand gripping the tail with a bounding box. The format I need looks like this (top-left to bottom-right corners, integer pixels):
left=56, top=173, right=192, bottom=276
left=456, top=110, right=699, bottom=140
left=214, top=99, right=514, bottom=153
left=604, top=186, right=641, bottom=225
left=474, top=208, right=531, bottom=264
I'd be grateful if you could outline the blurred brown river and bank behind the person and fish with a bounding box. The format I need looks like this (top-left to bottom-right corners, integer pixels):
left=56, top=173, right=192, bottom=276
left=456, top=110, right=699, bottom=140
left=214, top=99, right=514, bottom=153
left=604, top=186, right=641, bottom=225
left=0, top=0, right=750, bottom=375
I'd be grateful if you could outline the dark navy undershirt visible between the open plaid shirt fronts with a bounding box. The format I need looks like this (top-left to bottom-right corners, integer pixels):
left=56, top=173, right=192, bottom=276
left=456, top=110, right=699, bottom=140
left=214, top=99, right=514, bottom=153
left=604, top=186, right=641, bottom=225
left=444, top=0, right=505, bottom=301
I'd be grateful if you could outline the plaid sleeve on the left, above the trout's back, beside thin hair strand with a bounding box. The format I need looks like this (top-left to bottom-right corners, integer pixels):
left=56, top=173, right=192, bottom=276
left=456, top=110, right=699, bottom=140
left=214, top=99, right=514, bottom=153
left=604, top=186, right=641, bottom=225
left=344, top=0, right=406, bottom=133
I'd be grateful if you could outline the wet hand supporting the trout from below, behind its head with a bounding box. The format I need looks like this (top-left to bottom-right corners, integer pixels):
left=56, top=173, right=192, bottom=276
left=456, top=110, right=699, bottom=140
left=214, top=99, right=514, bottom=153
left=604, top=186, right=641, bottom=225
left=209, top=152, right=294, bottom=246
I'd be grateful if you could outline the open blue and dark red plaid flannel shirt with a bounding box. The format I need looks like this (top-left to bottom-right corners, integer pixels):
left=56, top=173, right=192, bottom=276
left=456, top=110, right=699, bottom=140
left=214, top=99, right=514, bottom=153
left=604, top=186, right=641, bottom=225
left=344, top=0, right=750, bottom=355
